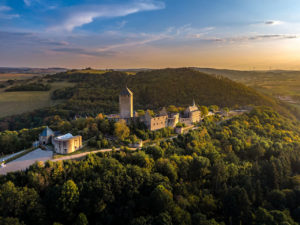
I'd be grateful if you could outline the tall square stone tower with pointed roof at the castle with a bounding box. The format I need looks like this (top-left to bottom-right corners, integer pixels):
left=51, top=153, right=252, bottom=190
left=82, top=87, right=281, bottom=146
left=119, top=86, right=133, bottom=119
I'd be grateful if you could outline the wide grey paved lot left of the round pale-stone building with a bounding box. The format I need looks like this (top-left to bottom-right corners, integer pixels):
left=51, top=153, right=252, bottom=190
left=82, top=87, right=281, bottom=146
left=0, top=148, right=53, bottom=175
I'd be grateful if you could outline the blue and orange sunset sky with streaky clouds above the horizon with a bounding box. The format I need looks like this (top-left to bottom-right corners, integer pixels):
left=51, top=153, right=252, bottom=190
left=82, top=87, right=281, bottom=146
left=0, top=0, right=300, bottom=70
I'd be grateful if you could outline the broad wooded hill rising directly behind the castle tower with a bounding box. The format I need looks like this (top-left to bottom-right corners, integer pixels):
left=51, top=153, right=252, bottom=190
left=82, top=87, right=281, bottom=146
left=51, top=68, right=277, bottom=112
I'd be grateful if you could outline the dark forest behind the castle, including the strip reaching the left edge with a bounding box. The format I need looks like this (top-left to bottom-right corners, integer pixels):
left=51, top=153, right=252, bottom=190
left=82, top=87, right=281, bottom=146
left=0, top=68, right=300, bottom=131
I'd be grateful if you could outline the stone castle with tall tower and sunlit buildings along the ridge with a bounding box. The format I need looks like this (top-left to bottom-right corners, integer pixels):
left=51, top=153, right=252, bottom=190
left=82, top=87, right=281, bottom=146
left=108, top=86, right=201, bottom=131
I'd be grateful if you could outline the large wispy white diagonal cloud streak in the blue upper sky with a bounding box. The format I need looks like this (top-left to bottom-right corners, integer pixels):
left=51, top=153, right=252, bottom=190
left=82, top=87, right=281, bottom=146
left=49, top=0, right=165, bottom=31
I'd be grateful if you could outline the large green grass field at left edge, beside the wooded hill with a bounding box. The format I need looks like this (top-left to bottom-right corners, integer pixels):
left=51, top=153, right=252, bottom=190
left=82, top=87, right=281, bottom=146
left=0, top=82, right=74, bottom=118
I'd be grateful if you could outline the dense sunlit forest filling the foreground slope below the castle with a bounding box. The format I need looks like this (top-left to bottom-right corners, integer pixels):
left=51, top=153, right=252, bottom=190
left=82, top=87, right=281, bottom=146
left=0, top=107, right=300, bottom=225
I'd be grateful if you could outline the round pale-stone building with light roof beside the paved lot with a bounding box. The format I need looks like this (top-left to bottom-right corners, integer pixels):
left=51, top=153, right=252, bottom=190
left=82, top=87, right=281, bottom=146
left=52, top=133, right=82, bottom=154
